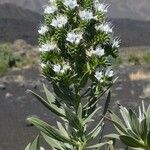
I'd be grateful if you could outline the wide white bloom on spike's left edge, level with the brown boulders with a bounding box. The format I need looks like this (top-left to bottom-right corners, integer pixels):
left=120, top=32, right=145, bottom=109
left=39, top=43, right=56, bottom=52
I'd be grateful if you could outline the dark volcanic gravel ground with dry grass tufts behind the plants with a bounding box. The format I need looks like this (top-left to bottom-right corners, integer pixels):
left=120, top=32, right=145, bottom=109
left=0, top=66, right=150, bottom=150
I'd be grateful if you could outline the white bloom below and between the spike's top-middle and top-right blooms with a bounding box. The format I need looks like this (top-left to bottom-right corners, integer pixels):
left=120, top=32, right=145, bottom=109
left=79, top=10, right=95, bottom=20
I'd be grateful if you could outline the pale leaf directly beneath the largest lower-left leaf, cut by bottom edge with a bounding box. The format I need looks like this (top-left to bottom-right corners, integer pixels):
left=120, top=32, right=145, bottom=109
left=41, top=132, right=65, bottom=150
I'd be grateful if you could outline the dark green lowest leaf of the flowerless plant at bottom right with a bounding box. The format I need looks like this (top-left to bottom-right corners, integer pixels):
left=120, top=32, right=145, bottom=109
left=120, top=135, right=144, bottom=148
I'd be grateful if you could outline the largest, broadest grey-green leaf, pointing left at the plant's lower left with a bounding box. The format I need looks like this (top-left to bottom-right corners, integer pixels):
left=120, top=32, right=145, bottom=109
left=27, top=117, right=77, bottom=146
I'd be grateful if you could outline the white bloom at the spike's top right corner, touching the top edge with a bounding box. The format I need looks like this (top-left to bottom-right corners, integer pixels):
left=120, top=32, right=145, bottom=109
left=94, top=0, right=109, bottom=13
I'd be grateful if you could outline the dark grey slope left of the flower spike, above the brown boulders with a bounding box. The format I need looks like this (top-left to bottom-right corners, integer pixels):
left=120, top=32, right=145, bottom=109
left=0, top=4, right=42, bottom=44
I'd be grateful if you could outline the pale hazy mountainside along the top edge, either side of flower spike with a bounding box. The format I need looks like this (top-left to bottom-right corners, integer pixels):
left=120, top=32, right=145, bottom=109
left=0, top=0, right=150, bottom=20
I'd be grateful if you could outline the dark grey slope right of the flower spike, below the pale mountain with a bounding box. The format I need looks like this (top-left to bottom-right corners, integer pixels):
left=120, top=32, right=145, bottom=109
left=112, top=19, right=150, bottom=46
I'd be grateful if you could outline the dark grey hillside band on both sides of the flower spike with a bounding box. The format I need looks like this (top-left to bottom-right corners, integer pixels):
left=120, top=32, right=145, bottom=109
left=0, top=4, right=150, bottom=46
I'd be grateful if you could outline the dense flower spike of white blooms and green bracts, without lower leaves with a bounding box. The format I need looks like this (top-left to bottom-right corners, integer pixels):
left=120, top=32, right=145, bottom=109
left=38, top=0, right=120, bottom=89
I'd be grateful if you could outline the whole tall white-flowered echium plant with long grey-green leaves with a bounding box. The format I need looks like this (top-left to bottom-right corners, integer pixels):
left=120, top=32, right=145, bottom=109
left=27, top=0, right=119, bottom=150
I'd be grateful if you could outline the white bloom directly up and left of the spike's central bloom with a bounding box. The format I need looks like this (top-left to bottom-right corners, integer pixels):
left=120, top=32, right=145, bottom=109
left=51, top=15, right=68, bottom=28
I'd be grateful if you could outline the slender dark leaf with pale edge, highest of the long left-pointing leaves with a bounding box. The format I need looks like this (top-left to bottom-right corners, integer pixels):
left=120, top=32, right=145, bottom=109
left=29, top=90, right=65, bottom=117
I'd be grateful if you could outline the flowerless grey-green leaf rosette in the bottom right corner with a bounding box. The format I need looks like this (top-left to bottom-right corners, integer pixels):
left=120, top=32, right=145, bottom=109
left=110, top=102, right=150, bottom=150
